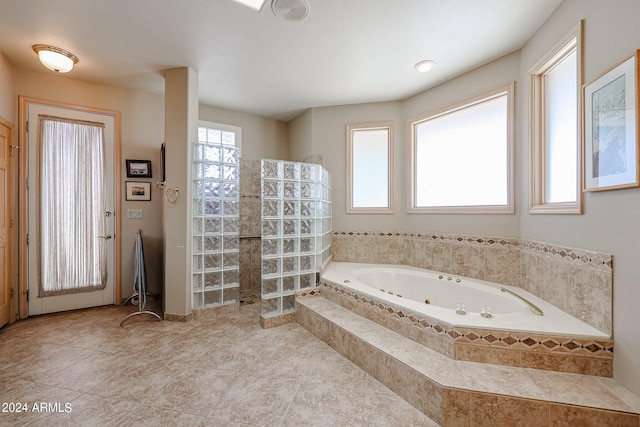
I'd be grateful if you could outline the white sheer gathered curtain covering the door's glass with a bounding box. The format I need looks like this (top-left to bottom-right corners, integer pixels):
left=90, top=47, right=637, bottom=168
left=39, top=115, right=107, bottom=296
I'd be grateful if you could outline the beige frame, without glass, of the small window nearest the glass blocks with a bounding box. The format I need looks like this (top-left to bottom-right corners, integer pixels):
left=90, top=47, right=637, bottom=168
left=346, top=121, right=395, bottom=214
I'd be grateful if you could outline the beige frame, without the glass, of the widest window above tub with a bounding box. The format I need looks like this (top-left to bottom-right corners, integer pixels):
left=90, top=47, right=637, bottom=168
left=407, top=82, right=515, bottom=215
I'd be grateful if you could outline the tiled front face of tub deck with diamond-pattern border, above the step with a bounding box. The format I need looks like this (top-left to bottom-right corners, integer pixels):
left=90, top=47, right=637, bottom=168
left=310, top=280, right=613, bottom=377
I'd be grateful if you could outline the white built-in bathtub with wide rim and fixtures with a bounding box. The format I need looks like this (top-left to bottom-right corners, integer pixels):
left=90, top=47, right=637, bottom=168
left=322, top=262, right=610, bottom=340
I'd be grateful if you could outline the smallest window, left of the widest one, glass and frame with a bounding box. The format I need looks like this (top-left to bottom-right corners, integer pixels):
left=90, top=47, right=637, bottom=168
left=347, top=122, right=393, bottom=213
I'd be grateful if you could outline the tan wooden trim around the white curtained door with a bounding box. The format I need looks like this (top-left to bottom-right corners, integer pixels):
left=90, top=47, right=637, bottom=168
left=18, top=96, right=121, bottom=319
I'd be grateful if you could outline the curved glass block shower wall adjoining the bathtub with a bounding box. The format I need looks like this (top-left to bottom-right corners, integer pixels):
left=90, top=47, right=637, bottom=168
left=261, top=160, right=331, bottom=317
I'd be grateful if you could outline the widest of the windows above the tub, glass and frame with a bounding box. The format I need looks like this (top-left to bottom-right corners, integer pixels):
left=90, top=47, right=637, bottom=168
left=409, top=84, right=514, bottom=214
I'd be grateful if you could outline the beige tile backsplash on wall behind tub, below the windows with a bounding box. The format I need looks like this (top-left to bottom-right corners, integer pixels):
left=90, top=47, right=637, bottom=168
left=332, top=231, right=613, bottom=336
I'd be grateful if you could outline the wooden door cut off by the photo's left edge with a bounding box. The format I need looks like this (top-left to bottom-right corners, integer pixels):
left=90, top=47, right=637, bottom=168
left=0, top=118, right=14, bottom=327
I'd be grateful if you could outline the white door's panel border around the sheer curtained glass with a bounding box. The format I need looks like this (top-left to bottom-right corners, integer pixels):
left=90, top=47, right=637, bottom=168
left=27, top=102, right=116, bottom=316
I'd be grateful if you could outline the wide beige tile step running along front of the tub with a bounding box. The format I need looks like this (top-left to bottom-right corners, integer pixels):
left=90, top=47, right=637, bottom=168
left=296, top=295, right=640, bottom=427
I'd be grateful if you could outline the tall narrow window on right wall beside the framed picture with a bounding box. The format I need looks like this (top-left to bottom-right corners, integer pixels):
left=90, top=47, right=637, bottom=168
left=529, top=24, right=582, bottom=214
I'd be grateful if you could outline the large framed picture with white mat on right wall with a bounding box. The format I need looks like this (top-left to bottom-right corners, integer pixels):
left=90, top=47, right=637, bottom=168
left=583, top=51, right=640, bottom=191
